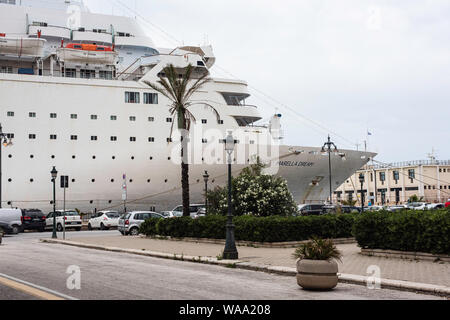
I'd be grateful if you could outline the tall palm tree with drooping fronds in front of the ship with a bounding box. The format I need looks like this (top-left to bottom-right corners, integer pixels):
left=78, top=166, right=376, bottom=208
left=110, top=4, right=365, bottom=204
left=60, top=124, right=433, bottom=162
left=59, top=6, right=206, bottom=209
left=145, top=64, right=220, bottom=216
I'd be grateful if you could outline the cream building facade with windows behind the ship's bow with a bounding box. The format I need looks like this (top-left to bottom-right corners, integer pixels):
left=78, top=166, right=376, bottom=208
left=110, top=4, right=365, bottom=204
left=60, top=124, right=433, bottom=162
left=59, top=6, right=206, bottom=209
left=333, top=159, right=450, bottom=205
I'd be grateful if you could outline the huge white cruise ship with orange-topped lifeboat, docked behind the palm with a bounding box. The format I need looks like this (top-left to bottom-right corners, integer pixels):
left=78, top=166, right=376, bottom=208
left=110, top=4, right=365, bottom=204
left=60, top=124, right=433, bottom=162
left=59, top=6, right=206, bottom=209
left=0, top=0, right=375, bottom=212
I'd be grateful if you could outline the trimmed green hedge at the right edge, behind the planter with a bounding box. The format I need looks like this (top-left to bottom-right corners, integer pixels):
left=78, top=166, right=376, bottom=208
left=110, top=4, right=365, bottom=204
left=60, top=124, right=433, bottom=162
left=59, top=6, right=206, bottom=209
left=353, top=210, right=450, bottom=254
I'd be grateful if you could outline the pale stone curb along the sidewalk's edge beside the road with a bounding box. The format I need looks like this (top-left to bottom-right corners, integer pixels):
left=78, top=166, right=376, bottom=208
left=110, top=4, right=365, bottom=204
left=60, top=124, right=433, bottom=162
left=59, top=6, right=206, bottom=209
left=39, top=239, right=450, bottom=299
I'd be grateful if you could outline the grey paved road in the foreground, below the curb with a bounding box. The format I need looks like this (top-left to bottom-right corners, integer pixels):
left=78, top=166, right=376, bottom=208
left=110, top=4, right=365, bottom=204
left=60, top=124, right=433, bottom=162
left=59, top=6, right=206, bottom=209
left=0, top=231, right=438, bottom=300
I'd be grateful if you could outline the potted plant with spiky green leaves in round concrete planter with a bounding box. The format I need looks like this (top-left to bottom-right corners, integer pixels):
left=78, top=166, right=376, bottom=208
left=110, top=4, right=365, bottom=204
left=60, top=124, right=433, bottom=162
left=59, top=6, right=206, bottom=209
left=293, top=239, right=342, bottom=290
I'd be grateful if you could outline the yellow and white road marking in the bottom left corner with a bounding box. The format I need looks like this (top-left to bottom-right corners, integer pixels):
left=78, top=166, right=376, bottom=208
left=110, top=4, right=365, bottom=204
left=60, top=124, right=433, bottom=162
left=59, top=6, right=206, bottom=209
left=0, top=273, right=78, bottom=300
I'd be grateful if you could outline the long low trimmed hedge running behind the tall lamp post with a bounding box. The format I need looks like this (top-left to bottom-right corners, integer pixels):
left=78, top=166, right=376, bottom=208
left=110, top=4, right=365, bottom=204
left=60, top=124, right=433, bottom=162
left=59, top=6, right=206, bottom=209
left=140, top=214, right=357, bottom=242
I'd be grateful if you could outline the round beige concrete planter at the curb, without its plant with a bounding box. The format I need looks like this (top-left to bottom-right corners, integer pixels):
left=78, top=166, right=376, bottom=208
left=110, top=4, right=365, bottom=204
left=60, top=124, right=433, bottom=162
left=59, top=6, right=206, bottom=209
left=297, top=259, right=338, bottom=290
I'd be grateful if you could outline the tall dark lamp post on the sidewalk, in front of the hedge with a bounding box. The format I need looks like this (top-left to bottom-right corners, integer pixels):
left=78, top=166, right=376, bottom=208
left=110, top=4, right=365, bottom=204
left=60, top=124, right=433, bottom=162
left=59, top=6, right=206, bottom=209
left=221, top=132, right=239, bottom=260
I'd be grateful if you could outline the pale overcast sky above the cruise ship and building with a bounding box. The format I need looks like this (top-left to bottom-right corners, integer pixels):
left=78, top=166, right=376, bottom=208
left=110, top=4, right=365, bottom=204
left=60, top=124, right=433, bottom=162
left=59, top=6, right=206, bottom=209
left=85, top=0, right=450, bottom=162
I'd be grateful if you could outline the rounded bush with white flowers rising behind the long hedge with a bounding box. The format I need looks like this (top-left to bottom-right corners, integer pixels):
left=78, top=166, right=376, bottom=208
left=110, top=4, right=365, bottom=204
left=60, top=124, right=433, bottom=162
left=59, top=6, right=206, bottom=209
left=208, top=160, right=297, bottom=217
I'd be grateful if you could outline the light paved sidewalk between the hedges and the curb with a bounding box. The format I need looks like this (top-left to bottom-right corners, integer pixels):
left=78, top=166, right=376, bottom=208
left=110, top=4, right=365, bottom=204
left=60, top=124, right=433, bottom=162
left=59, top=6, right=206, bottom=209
left=42, top=234, right=450, bottom=292
